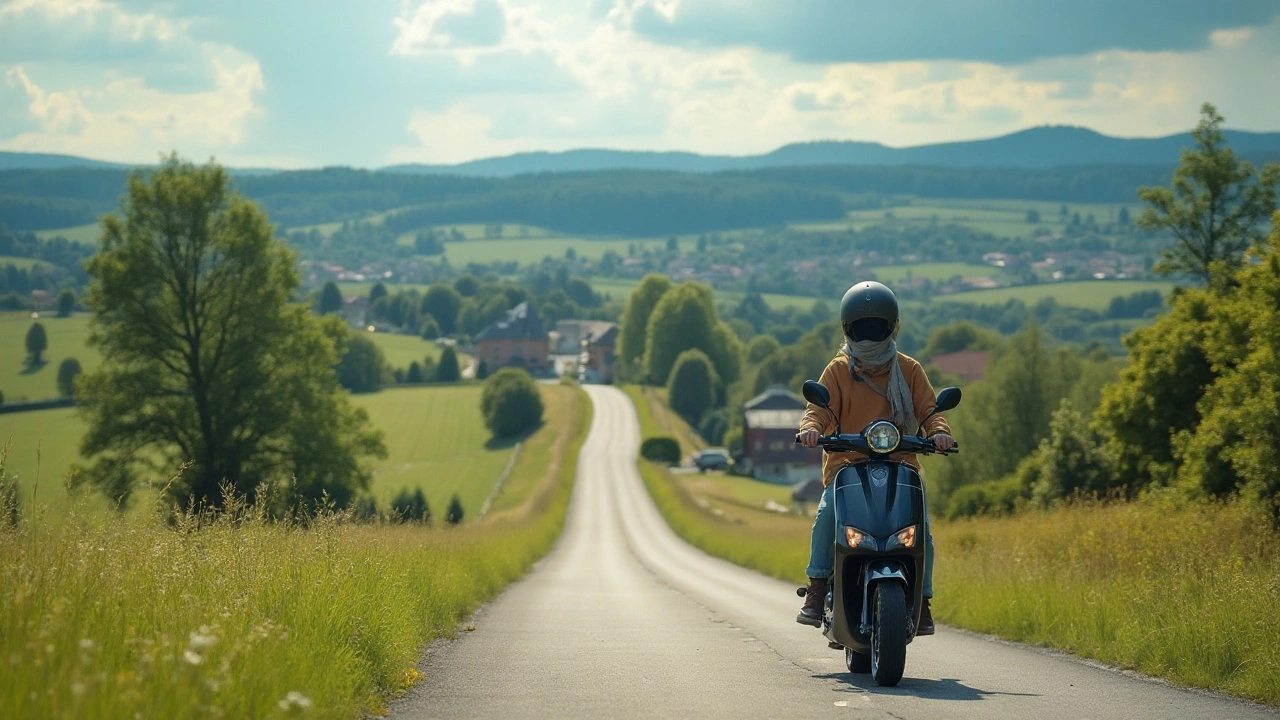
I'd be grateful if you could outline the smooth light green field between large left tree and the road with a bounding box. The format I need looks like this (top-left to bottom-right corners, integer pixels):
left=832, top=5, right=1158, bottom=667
left=352, top=384, right=517, bottom=519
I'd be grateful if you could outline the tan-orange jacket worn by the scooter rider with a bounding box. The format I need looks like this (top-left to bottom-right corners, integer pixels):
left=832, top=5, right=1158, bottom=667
left=800, top=352, right=951, bottom=487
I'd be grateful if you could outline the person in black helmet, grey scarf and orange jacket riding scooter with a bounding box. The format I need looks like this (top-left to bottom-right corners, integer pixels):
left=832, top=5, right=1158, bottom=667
left=796, top=282, right=955, bottom=635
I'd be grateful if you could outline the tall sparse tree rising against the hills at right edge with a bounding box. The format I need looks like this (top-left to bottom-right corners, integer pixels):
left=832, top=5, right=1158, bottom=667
left=1138, top=102, right=1280, bottom=282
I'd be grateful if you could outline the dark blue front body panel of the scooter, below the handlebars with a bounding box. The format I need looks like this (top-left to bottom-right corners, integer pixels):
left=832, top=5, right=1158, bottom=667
left=824, top=457, right=925, bottom=653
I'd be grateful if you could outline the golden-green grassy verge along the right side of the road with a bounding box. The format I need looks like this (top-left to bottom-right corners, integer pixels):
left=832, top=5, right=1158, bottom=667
left=631, top=392, right=1280, bottom=705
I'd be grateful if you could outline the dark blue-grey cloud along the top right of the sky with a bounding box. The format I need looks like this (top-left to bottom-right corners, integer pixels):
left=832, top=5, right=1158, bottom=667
left=616, top=0, right=1280, bottom=64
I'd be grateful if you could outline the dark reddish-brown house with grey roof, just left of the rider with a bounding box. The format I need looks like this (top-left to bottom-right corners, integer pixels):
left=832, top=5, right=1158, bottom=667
left=742, top=386, right=822, bottom=484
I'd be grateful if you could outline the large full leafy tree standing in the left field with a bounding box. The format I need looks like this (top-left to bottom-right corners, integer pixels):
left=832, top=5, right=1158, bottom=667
left=78, top=156, right=385, bottom=507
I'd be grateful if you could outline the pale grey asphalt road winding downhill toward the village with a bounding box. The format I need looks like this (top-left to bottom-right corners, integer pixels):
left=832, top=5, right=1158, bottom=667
left=390, top=387, right=1277, bottom=719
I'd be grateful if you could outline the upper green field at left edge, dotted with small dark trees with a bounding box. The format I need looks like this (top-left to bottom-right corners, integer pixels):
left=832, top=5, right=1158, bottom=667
left=0, top=313, right=101, bottom=402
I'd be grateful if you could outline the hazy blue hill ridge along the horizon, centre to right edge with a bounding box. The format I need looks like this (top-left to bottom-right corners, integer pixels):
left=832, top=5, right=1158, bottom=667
left=384, top=126, right=1280, bottom=177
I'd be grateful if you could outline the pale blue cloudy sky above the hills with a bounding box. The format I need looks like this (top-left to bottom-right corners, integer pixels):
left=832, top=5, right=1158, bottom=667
left=0, top=0, right=1280, bottom=168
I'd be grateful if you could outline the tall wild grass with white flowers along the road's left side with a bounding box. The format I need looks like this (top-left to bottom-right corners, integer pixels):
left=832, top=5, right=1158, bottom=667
left=0, top=387, right=590, bottom=719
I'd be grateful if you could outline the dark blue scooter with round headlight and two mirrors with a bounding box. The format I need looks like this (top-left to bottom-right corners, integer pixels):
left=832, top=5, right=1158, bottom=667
left=796, top=380, right=960, bottom=687
